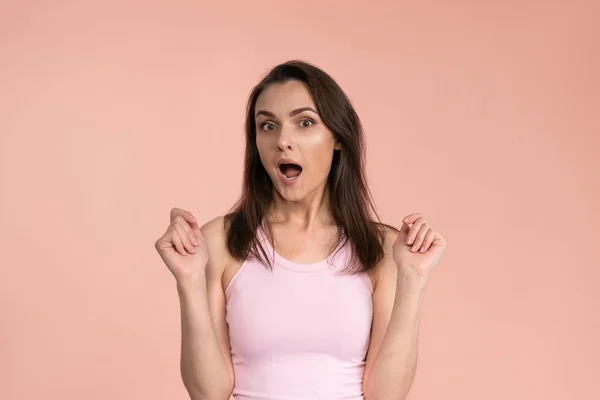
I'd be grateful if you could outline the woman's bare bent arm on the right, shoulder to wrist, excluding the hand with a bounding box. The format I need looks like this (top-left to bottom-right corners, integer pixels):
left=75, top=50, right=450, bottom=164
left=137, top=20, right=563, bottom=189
left=363, top=230, right=426, bottom=400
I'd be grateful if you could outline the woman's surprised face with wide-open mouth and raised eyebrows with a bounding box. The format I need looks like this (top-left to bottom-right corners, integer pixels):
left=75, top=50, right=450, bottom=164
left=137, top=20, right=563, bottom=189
left=254, top=80, right=340, bottom=201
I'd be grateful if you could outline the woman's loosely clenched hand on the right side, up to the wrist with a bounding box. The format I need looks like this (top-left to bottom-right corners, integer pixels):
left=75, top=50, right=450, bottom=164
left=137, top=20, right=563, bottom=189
left=394, top=213, right=446, bottom=278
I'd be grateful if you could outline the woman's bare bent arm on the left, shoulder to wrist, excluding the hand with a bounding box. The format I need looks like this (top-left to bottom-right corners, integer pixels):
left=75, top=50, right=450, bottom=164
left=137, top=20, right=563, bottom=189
left=177, top=217, right=233, bottom=400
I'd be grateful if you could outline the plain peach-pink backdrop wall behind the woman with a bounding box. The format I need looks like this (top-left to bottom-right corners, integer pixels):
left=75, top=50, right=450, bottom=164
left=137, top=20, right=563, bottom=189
left=0, top=0, right=600, bottom=400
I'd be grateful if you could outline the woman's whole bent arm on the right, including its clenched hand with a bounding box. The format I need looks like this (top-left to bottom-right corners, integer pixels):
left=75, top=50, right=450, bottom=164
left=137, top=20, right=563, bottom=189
left=363, top=214, right=446, bottom=400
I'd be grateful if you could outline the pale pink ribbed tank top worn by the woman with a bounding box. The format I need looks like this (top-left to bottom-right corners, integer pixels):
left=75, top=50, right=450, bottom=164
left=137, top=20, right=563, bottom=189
left=225, top=229, right=373, bottom=400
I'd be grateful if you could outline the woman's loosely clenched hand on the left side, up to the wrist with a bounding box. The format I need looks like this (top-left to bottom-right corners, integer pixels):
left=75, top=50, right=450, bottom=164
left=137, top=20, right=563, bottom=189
left=154, top=208, right=208, bottom=281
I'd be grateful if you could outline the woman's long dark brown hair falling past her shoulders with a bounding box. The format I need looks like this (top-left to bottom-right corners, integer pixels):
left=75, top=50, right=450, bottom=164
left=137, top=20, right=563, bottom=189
left=225, top=60, right=395, bottom=273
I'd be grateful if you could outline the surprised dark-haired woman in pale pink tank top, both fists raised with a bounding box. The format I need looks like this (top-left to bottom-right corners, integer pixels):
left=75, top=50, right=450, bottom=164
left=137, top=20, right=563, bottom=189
left=155, top=61, right=446, bottom=400
